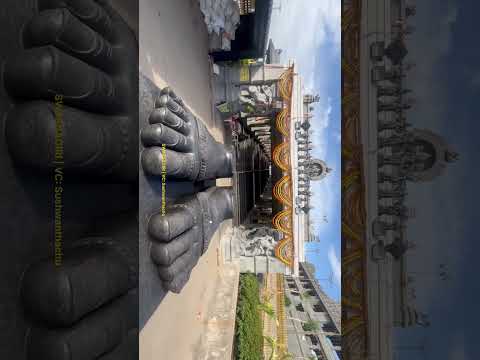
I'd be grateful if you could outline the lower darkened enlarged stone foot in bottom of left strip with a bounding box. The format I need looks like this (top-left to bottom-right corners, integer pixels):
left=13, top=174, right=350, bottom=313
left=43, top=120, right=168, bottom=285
left=21, top=237, right=138, bottom=360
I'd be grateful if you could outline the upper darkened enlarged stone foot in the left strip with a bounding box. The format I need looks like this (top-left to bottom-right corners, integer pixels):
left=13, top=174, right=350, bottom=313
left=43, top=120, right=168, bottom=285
left=4, top=0, right=138, bottom=181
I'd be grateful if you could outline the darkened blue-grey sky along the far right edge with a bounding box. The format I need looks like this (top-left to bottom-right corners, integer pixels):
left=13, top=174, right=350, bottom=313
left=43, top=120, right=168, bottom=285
left=388, top=0, right=480, bottom=360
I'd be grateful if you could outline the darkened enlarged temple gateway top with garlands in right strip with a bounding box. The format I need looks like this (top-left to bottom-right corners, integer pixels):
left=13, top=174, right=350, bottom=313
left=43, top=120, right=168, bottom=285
left=342, top=0, right=459, bottom=360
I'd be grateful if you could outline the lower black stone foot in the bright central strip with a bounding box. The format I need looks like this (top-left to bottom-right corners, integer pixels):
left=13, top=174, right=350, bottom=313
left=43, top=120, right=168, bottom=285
left=147, top=187, right=233, bottom=293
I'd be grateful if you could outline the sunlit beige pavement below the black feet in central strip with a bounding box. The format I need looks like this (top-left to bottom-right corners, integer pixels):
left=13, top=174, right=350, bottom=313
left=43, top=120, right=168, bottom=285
left=140, top=220, right=239, bottom=360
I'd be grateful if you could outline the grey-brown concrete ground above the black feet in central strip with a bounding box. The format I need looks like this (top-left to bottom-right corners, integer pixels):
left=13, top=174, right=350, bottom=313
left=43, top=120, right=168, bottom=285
left=139, top=0, right=217, bottom=128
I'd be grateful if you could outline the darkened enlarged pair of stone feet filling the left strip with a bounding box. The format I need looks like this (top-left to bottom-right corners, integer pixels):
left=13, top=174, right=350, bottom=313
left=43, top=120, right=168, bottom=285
left=0, top=0, right=138, bottom=360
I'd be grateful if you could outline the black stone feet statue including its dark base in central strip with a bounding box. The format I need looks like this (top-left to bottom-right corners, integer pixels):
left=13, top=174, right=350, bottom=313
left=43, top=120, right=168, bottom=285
left=139, top=78, right=235, bottom=320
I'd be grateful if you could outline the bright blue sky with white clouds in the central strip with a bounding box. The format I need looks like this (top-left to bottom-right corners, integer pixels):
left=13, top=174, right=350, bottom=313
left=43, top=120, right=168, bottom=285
left=270, top=0, right=341, bottom=300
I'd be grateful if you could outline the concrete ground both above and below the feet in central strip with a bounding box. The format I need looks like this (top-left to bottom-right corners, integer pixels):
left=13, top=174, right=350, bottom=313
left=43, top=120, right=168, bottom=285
left=139, top=0, right=238, bottom=360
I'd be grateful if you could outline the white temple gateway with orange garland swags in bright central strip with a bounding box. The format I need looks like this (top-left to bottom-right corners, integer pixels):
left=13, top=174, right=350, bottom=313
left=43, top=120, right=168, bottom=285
left=224, top=58, right=331, bottom=276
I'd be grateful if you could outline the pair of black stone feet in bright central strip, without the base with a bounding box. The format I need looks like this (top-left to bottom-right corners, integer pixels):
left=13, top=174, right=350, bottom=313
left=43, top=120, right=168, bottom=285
left=140, top=79, right=233, bottom=293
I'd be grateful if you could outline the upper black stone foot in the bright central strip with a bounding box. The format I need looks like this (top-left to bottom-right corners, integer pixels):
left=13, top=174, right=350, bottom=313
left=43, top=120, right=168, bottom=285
left=141, top=88, right=232, bottom=181
